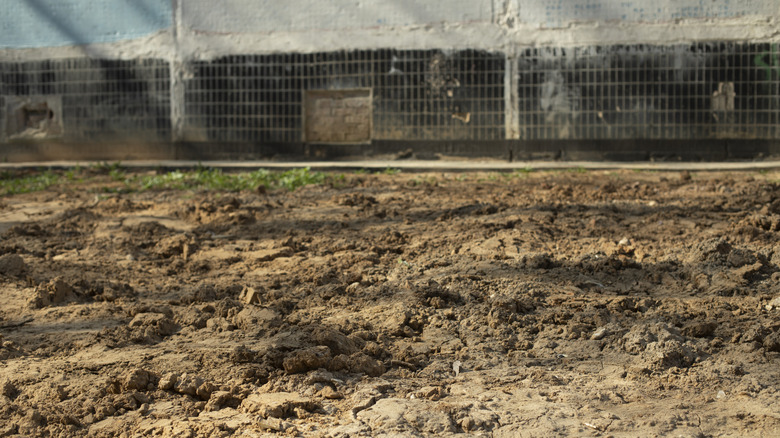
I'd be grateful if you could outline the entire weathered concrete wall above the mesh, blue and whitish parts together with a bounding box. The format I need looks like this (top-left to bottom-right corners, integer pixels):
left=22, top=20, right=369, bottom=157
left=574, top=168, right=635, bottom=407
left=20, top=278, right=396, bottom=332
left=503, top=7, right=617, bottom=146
left=0, top=0, right=780, bottom=61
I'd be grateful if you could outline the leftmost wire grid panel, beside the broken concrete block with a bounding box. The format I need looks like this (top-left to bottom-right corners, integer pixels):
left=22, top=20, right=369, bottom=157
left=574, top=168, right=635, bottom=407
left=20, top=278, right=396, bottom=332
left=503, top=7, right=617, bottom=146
left=0, top=58, right=171, bottom=141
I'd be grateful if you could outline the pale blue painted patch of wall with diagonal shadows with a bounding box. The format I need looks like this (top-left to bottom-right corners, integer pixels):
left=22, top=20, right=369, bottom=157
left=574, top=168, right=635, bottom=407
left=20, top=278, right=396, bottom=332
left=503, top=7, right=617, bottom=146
left=0, top=0, right=173, bottom=49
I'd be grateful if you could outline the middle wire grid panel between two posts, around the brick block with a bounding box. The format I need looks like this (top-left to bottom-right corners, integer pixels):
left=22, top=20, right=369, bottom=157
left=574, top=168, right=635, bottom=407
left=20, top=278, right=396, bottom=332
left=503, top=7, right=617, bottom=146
left=185, top=50, right=505, bottom=143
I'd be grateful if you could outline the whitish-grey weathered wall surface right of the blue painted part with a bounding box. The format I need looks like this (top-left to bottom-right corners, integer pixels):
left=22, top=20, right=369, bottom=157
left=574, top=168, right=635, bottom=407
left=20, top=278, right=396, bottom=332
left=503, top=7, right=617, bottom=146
left=178, top=0, right=780, bottom=59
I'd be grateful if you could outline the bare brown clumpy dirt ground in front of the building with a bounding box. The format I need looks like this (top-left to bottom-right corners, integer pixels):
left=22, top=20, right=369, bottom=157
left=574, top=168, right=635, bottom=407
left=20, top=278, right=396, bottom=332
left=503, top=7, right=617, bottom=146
left=0, top=171, right=780, bottom=437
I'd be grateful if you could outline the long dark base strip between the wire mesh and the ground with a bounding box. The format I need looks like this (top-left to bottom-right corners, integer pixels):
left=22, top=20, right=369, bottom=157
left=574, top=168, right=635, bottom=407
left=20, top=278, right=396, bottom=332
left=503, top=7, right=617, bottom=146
left=0, top=139, right=780, bottom=167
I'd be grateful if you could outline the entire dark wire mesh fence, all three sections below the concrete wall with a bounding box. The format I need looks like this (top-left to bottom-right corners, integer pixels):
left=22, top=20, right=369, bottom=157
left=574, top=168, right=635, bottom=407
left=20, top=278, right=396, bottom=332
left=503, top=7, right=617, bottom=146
left=0, top=42, right=780, bottom=147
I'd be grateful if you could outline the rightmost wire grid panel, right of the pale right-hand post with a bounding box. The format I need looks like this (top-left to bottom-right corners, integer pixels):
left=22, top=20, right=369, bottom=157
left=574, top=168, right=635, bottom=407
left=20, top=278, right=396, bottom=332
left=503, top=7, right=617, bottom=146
left=518, top=43, right=780, bottom=140
